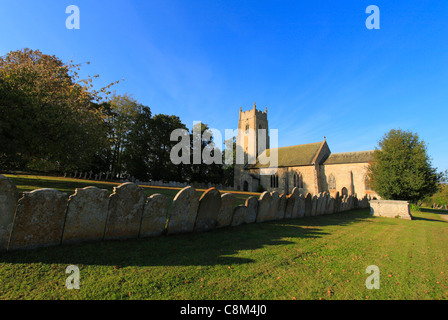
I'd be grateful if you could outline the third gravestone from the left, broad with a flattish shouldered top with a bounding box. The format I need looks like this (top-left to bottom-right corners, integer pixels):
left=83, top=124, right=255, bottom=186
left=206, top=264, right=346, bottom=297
left=62, top=187, right=109, bottom=243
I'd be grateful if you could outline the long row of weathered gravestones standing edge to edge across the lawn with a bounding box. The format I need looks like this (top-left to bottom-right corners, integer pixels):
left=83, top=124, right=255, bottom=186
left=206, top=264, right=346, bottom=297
left=0, top=175, right=369, bottom=251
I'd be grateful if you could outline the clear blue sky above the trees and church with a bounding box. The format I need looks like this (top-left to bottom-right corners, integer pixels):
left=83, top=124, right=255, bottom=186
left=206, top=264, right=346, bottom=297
left=0, top=0, right=448, bottom=171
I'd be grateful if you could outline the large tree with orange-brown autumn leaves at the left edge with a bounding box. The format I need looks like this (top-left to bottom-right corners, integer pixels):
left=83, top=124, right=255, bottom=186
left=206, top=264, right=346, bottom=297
left=0, top=49, right=117, bottom=171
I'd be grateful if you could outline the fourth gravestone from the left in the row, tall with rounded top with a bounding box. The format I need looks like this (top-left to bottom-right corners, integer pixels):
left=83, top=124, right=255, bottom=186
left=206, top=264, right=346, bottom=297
left=104, top=182, right=145, bottom=240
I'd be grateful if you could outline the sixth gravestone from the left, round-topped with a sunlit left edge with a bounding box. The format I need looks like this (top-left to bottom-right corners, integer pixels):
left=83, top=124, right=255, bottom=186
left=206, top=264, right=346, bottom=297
left=168, top=186, right=199, bottom=234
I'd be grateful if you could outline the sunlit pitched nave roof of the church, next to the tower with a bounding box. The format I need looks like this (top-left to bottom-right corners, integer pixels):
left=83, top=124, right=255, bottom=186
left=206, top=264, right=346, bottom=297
left=248, top=140, right=325, bottom=169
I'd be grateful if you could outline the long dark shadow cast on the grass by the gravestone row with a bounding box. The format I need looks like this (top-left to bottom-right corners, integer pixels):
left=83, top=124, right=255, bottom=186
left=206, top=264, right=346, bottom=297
left=0, top=210, right=370, bottom=267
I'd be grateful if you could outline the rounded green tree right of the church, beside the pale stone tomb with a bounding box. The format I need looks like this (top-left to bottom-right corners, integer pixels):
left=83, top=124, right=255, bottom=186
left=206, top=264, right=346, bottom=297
left=368, top=129, right=439, bottom=203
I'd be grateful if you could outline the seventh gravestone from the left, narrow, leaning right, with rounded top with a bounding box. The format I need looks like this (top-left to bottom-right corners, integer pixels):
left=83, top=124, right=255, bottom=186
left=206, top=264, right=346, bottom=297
left=194, top=188, right=221, bottom=232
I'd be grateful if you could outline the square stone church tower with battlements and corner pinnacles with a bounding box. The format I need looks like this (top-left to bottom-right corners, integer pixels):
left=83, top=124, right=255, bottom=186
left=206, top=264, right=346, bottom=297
left=234, top=103, right=269, bottom=190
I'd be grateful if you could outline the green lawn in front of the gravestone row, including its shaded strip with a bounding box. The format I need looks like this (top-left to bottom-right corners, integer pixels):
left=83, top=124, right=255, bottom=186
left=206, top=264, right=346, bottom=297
left=0, top=210, right=448, bottom=300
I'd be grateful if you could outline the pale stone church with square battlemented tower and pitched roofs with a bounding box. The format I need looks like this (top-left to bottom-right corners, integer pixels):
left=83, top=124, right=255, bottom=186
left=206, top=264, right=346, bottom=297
left=234, top=103, right=379, bottom=198
